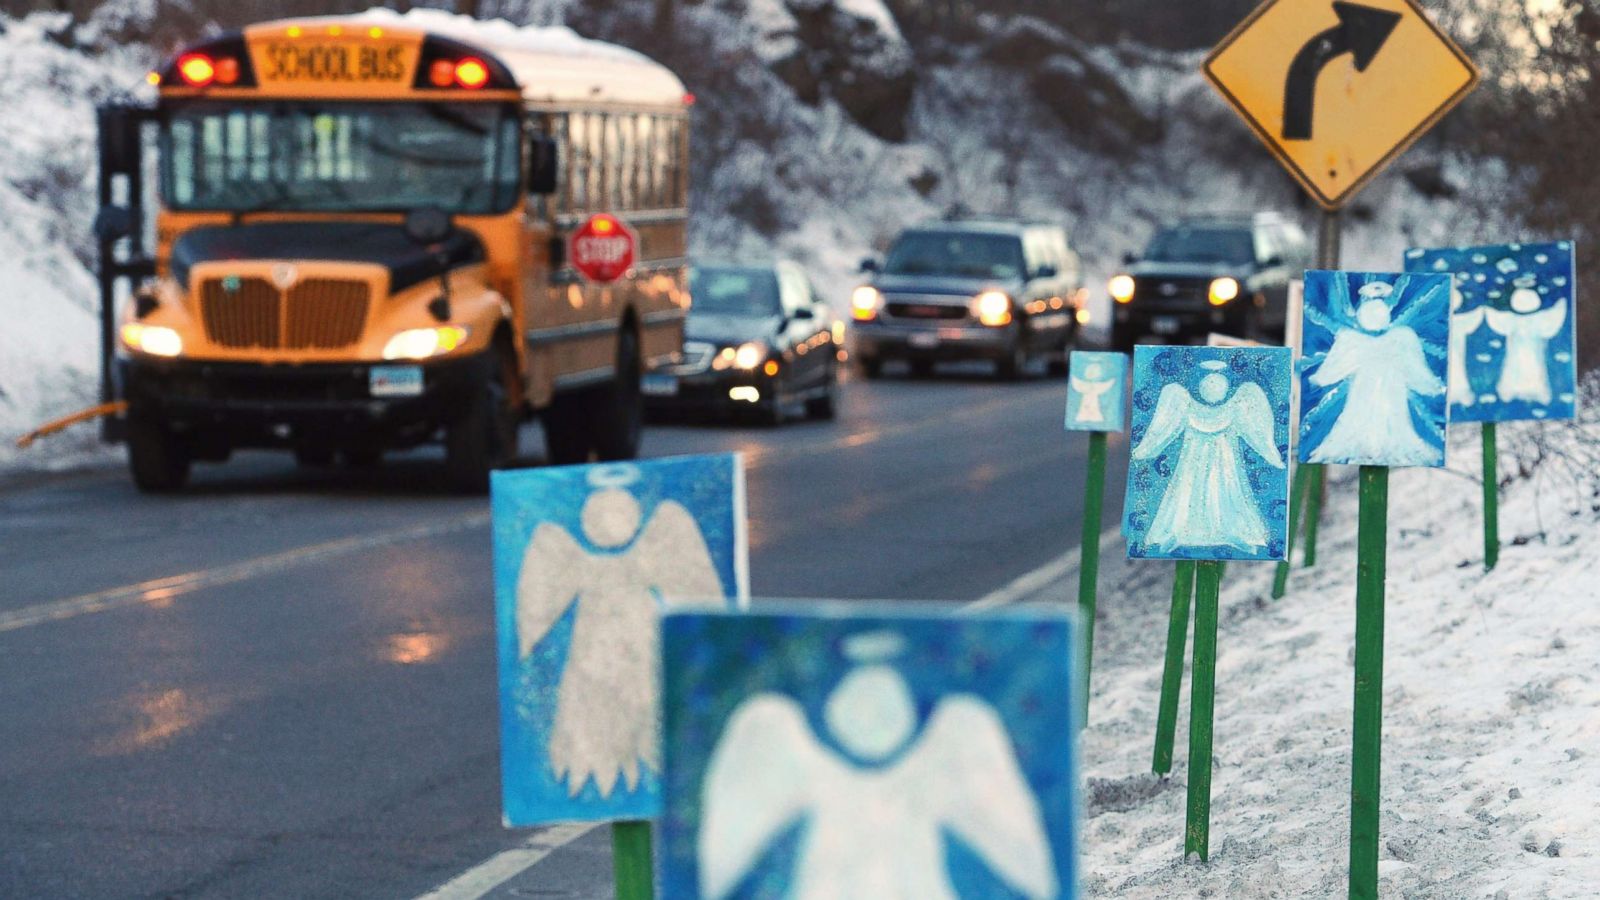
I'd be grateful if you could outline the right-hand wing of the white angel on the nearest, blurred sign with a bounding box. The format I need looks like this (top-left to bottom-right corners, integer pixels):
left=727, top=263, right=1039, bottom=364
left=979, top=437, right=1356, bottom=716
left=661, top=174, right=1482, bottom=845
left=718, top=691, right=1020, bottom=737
left=902, top=693, right=1061, bottom=900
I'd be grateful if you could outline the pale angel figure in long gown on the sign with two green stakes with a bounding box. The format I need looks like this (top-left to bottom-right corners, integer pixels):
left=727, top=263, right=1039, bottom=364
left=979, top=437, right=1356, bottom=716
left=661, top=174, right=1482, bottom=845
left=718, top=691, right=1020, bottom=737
left=1133, top=360, right=1285, bottom=552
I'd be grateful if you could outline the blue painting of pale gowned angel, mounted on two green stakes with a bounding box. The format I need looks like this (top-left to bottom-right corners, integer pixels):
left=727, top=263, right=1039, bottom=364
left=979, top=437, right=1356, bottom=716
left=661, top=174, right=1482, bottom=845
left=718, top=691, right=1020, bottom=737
left=1123, top=346, right=1293, bottom=559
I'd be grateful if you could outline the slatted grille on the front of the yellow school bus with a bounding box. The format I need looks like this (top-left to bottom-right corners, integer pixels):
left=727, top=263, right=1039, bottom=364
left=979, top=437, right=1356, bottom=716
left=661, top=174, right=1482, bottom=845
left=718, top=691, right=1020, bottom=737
left=200, top=279, right=371, bottom=351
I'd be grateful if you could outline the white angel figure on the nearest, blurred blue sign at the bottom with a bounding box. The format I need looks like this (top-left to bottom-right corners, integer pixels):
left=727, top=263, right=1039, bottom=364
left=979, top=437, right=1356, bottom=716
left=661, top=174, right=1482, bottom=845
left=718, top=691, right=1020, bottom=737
left=696, top=633, right=1061, bottom=900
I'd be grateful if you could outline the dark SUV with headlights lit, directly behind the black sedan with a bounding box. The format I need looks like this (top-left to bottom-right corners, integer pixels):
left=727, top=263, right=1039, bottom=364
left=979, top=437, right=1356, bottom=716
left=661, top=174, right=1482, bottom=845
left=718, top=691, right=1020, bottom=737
left=850, top=221, right=1088, bottom=378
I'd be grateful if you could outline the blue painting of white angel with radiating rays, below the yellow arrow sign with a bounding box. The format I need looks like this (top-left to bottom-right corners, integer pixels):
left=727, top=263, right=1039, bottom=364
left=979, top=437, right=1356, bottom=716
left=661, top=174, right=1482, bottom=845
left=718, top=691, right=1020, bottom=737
left=1299, top=271, right=1450, bottom=466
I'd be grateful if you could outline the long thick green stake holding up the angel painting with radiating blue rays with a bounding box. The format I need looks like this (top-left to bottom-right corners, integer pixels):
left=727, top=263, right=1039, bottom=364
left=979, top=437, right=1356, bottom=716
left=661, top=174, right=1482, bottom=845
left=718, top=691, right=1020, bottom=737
left=1350, top=466, right=1389, bottom=900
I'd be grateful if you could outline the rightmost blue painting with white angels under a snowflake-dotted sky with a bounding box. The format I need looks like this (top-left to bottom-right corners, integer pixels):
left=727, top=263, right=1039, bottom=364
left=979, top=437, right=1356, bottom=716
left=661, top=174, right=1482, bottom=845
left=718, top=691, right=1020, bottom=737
left=1405, top=240, right=1578, bottom=421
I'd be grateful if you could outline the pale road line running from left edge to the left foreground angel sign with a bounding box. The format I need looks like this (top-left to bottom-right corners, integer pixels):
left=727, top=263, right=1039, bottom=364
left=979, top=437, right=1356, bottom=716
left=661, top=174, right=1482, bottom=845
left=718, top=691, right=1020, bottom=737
left=0, top=512, right=490, bottom=634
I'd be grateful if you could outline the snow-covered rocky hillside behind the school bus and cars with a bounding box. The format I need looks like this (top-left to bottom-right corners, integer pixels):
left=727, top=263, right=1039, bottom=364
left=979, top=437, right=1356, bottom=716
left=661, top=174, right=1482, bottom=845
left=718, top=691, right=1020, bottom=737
left=0, top=0, right=1526, bottom=464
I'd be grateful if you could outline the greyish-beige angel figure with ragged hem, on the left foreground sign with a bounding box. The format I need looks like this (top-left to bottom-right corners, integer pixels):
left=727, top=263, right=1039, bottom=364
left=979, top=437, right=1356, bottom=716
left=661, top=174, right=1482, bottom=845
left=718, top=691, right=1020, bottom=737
left=517, top=464, right=723, bottom=796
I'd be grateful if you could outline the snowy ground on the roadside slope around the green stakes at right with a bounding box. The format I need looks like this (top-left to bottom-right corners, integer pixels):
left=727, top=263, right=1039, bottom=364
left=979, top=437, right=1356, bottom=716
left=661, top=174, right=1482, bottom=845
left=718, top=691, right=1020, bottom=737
left=1082, top=383, right=1600, bottom=900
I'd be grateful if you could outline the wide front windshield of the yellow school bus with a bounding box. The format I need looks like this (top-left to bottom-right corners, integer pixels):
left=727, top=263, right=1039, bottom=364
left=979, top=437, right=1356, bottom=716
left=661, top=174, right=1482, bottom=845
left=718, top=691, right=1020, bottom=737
left=162, top=101, right=522, bottom=215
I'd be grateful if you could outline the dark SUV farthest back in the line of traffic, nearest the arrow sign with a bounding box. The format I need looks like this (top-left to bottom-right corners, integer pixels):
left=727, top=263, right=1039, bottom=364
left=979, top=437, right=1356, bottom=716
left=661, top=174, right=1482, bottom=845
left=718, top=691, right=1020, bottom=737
left=1107, top=213, right=1310, bottom=349
